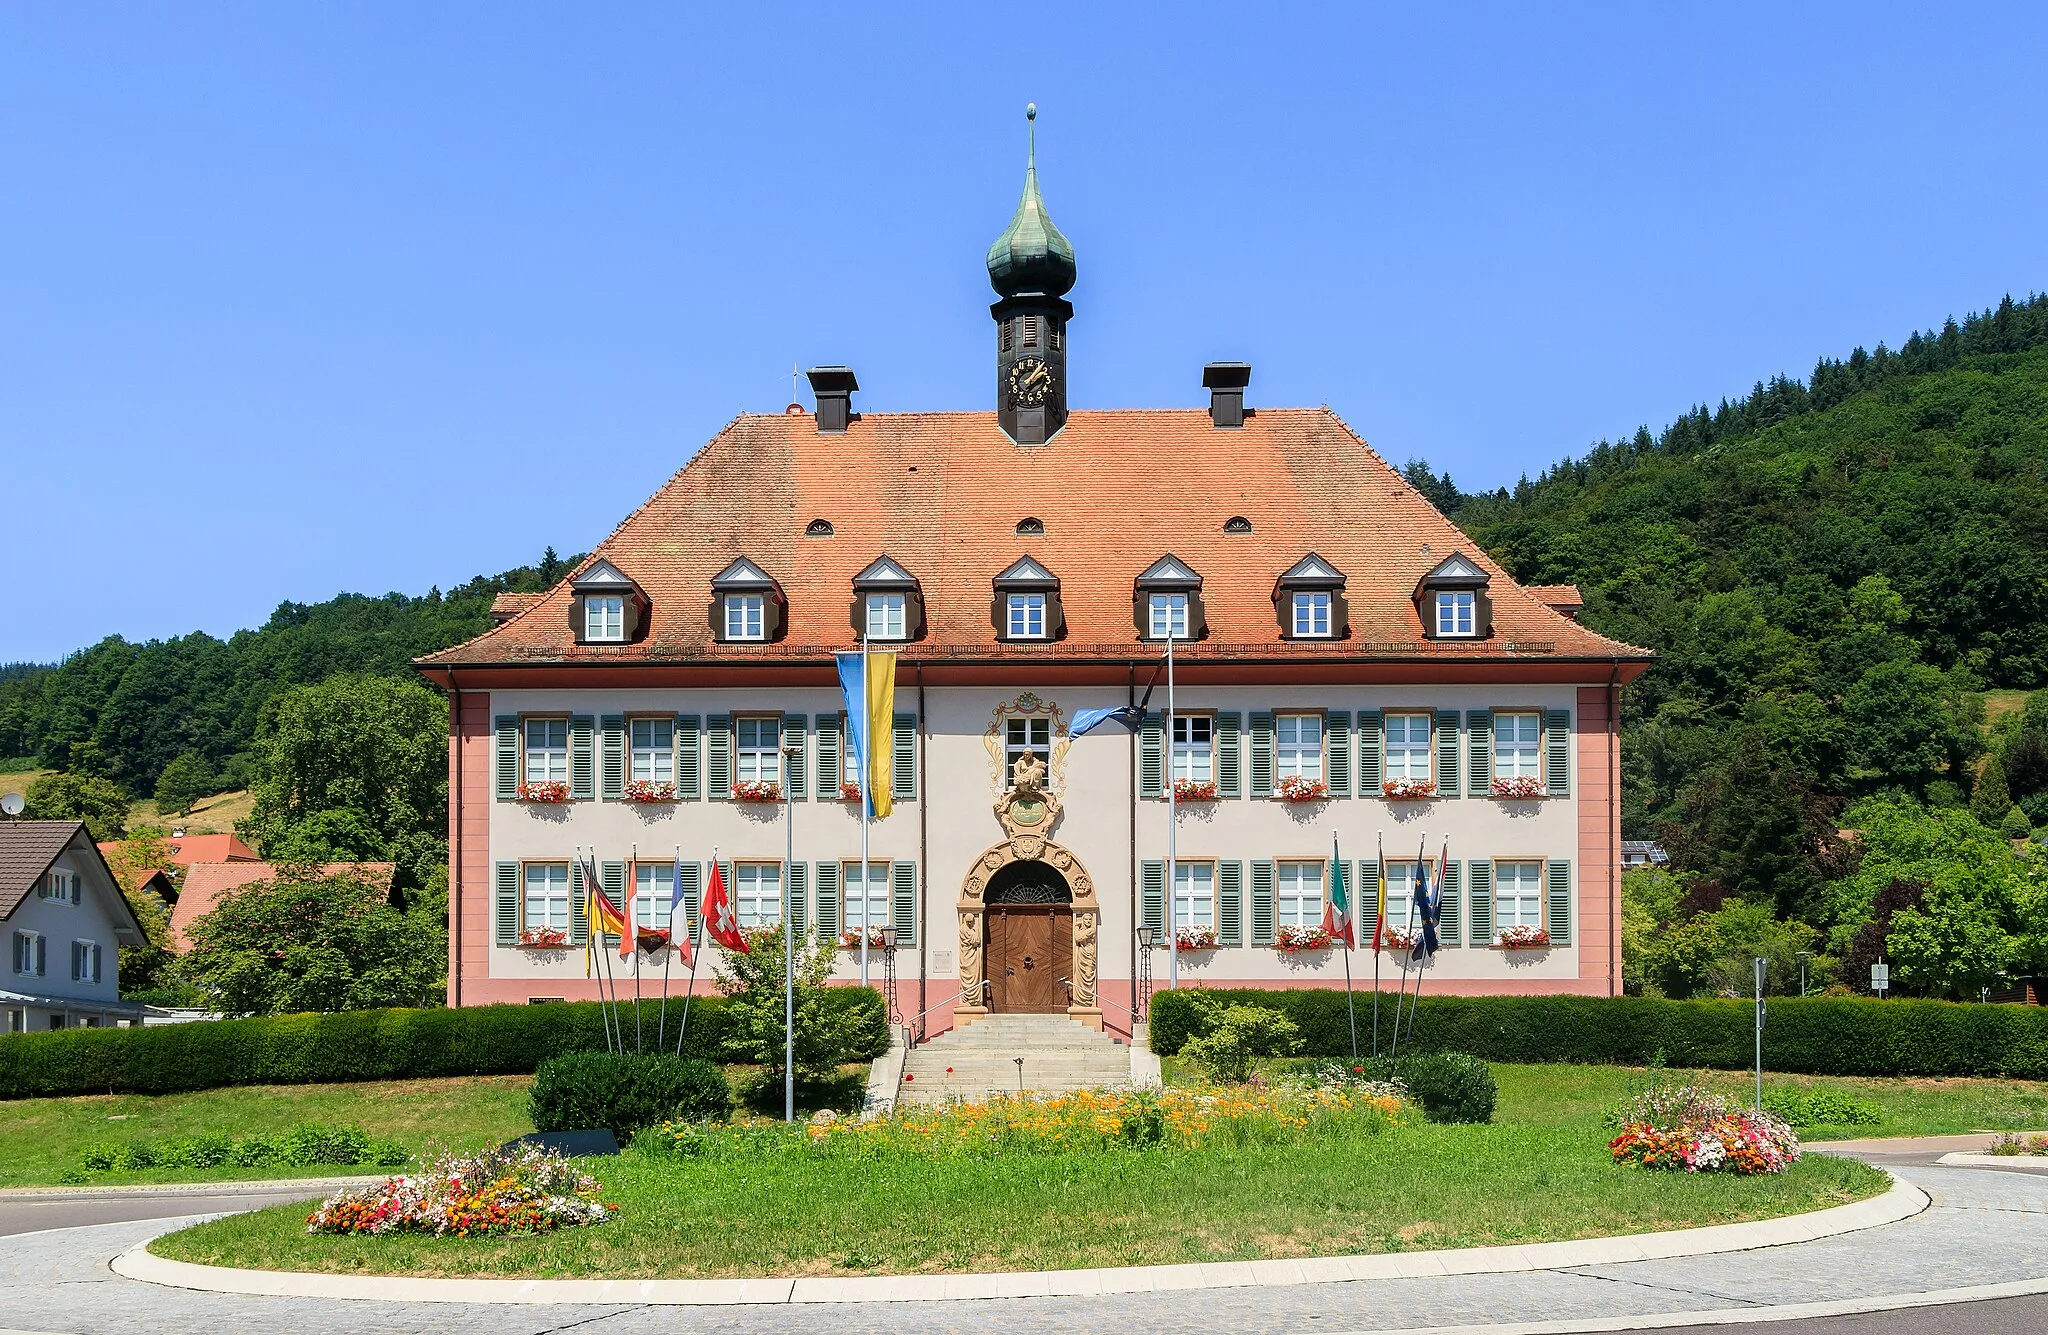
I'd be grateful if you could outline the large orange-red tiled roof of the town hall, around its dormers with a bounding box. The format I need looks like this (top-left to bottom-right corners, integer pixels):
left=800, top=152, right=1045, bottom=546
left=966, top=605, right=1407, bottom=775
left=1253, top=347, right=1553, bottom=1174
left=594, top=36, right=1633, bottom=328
left=420, top=407, right=1649, bottom=668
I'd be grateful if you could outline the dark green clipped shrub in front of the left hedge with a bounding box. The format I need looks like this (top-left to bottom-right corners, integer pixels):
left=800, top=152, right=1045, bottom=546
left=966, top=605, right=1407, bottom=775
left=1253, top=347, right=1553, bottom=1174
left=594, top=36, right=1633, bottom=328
left=528, top=1052, right=733, bottom=1145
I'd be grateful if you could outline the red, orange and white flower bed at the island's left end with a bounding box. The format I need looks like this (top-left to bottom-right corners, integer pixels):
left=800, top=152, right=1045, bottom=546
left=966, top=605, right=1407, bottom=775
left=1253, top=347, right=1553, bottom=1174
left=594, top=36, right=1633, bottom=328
left=305, top=1145, right=612, bottom=1237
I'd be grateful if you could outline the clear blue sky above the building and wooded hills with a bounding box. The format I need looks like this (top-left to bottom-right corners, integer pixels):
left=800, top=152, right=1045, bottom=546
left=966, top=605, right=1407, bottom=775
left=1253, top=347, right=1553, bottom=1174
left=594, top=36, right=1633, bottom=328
left=0, top=0, right=2048, bottom=661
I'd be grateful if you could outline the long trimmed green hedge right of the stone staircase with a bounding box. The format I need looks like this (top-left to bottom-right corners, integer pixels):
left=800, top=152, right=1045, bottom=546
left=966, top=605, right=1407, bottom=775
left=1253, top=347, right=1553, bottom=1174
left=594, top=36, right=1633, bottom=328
left=1151, top=989, right=2048, bottom=1079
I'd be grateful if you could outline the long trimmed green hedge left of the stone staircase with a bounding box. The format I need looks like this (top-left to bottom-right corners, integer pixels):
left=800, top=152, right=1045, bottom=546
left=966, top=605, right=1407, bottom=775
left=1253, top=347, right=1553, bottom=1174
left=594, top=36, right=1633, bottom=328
left=0, top=987, right=889, bottom=1100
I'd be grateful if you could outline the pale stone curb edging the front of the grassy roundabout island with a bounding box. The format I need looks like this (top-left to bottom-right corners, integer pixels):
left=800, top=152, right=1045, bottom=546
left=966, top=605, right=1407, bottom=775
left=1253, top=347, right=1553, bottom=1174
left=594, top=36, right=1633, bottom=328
left=113, top=1175, right=1929, bottom=1302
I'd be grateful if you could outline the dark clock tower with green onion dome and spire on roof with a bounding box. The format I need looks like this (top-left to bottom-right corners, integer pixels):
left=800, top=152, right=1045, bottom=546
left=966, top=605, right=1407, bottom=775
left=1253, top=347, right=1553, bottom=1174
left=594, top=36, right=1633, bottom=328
left=989, top=102, right=1075, bottom=444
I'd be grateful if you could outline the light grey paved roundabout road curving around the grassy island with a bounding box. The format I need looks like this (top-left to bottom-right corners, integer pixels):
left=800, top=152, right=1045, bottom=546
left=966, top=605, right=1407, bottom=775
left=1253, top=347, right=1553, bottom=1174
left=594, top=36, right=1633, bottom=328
left=0, top=1165, right=2048, bottom=1335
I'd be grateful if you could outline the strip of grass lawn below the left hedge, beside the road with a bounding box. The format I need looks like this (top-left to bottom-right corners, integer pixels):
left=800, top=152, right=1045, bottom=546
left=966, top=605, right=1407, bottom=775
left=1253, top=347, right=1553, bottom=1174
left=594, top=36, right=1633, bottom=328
left=0, top=1075, right=532, bottom=1188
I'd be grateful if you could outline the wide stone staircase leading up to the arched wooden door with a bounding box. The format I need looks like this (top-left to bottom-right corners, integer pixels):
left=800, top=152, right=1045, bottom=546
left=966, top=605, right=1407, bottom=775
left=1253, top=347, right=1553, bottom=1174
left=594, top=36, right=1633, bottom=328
left=897, top=1016, right=1130, bottom=1104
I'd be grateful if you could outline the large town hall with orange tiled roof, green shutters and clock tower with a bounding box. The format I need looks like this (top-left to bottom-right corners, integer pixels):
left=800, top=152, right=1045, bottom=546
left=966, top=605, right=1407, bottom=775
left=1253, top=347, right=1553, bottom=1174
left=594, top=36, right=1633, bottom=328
left=418, top=114, right=1651, bottom=1034
